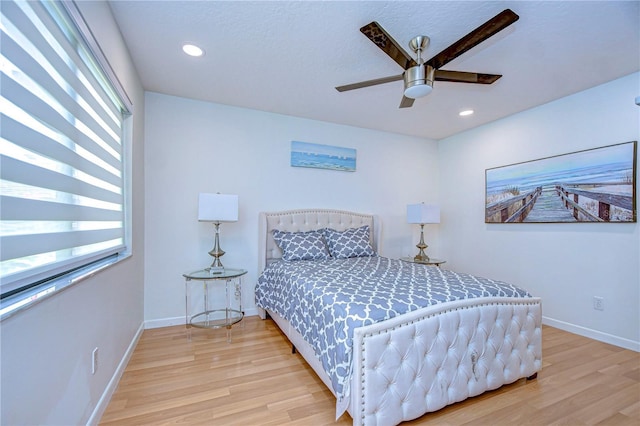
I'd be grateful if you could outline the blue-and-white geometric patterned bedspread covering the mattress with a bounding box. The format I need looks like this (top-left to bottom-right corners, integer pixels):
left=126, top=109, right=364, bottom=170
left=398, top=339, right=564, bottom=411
left=255, top=256, right=531, bottom=405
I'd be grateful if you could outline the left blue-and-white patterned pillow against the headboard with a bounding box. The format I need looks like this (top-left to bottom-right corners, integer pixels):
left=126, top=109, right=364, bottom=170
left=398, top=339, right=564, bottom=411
left=273, top=229, right=329, bottom=260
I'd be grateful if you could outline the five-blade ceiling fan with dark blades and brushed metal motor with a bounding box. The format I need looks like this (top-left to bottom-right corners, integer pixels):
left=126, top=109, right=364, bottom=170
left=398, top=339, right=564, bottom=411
left=336, top=9, right=519, bottom=108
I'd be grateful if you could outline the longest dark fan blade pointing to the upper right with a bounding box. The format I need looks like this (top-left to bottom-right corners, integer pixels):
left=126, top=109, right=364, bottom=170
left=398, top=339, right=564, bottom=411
left=426, top=9, right=520, bottom=69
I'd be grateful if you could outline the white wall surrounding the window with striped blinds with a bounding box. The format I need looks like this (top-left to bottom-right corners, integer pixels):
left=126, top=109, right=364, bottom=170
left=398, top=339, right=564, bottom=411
left=0, top=2, right=144, bottom=425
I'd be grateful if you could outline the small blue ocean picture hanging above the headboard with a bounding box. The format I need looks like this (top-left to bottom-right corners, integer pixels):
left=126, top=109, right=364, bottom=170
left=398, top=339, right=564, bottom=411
left=291, top=141, right=356, bottom=172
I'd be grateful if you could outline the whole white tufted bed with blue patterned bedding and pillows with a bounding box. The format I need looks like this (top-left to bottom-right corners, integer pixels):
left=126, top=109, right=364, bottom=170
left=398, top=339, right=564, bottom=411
left=256, top=209, right=542, bottom=425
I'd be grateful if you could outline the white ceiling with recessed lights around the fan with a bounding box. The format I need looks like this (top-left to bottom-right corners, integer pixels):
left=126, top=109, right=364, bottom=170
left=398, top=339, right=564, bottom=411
left=110, top=0, right=640, bottom=139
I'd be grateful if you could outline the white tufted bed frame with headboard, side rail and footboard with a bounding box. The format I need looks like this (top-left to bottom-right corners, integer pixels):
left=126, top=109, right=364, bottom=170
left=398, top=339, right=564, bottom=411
left=259, top=210, right=542, bottom=425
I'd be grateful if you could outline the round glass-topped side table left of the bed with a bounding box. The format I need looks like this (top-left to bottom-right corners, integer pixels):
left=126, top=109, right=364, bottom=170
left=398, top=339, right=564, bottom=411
left=182, top=268, right=247, bottom=343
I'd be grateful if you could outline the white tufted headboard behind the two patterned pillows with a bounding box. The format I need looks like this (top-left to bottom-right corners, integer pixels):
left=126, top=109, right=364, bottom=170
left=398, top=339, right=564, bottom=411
left=258, top=209, right=380, bottom=273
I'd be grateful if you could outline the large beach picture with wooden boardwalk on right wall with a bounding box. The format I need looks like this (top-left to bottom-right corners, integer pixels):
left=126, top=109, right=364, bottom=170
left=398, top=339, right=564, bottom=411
left=485, top=141, right=638, bottom=223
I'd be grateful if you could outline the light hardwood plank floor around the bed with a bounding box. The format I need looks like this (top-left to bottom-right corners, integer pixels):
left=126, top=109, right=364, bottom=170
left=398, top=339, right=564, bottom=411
left=100, top=317, right=640, bottom=425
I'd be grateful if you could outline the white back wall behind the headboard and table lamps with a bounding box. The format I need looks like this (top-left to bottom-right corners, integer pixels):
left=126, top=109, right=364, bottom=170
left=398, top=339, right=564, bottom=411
left=145, top=93, right=438, bottom=327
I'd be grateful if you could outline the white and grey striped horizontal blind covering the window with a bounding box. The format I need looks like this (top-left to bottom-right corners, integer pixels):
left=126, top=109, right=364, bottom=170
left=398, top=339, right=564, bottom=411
left=0, top=0, right=128, bottom=297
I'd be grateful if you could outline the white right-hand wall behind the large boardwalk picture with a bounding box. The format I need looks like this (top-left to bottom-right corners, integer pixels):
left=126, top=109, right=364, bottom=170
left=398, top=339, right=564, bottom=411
left=439, top=73, right=640, bottom=351
